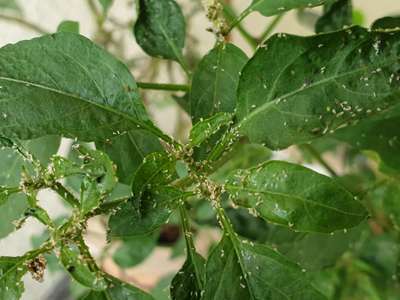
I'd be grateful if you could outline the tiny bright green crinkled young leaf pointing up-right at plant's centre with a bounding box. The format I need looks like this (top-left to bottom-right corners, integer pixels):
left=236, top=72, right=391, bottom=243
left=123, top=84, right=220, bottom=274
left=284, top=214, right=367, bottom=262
left=189, top=113, right=232, bottom=147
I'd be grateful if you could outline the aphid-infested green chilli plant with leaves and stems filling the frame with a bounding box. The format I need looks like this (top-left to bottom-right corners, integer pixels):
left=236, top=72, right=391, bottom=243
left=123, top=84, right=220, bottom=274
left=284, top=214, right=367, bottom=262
left=0, top=0, right=400, bottom=300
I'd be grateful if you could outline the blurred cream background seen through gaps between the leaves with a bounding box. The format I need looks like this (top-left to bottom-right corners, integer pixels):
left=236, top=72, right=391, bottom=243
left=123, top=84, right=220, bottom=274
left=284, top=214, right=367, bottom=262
left=0, top=0, right=400, bottom=300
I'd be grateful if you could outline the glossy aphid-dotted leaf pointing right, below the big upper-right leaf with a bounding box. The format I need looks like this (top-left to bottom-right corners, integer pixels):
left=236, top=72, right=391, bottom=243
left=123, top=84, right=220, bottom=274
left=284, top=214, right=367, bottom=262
left=225, top=161, right=367, bottom=233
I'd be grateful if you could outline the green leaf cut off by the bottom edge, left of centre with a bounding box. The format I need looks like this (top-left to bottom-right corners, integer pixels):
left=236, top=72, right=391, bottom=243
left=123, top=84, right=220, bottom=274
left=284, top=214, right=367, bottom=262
left=82, top=275, right=154, bottom=300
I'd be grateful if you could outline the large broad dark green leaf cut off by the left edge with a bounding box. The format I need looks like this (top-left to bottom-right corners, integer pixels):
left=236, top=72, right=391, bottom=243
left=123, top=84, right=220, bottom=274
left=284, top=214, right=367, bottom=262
left=0, top=32, right=160, bottom=141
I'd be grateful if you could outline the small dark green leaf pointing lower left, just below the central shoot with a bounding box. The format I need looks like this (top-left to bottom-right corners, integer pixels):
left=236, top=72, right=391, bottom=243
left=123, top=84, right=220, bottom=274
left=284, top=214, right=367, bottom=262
left=108, top=187, right=184, bottom=238
